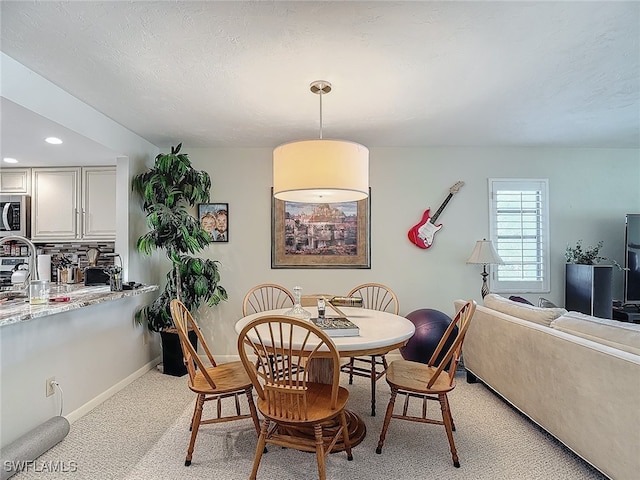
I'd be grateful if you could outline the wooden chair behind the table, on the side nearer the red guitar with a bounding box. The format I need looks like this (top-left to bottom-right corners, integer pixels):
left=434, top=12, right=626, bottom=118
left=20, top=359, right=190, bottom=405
left=340, top=283, right=400, bottom=417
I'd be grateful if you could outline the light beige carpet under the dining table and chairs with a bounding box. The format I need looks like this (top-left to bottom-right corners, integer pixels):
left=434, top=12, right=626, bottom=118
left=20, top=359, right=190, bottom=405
left=12, top=370, right=606, bottom=480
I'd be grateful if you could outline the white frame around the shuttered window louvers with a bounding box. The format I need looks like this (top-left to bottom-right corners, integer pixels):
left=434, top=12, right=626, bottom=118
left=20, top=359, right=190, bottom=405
left=488, top=178, right=551, bottom=293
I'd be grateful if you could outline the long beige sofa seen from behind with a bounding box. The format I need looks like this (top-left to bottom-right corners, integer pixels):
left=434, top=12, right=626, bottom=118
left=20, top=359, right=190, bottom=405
left=455, top=295, right=640, bottom=480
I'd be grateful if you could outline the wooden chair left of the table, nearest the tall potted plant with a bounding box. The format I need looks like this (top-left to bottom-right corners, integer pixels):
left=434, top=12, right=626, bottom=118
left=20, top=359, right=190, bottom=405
left=170, top=300, right=260, bottom=467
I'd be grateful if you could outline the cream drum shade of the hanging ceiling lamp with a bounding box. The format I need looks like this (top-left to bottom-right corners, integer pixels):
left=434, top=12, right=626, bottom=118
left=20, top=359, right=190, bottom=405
left=273, top=139, right=369, bottom=203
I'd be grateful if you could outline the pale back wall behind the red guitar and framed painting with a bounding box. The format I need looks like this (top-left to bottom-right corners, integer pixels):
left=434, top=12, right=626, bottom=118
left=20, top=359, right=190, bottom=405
left=183, top=145, right=640, bottom=355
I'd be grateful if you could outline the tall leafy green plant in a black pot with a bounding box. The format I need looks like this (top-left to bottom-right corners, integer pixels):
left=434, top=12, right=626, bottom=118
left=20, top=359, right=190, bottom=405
left=132, top=144, right=227, bottom=375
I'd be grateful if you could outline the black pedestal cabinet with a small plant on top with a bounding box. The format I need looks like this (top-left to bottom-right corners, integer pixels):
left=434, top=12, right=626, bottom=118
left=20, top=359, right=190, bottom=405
left=564, top=263, right=613, bottom=318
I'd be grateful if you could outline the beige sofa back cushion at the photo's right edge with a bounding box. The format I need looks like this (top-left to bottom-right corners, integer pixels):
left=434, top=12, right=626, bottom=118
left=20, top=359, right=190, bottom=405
left=551, top=312, right=640, bottom=355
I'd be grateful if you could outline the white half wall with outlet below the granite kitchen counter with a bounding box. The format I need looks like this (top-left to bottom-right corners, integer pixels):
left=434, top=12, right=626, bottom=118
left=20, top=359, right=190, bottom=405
left=0, top=294, right=156, bottom=447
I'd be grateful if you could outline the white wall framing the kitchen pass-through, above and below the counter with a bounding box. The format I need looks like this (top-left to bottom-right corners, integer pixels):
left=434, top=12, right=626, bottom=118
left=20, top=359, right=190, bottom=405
left=0, top=53, right=160, bottom=446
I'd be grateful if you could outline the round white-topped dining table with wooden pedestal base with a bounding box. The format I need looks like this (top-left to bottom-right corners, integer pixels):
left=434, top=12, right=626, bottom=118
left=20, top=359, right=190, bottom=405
left=235, top=307, right=415, bottom=451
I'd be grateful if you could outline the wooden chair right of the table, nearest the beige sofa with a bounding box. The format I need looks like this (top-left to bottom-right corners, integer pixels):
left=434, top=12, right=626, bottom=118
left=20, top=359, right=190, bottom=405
left=376, top=300, right=476, bottom=467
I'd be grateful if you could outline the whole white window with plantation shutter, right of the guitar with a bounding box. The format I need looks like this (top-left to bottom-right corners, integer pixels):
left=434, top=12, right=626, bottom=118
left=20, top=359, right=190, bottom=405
left=489, top=178, right=550, bottom=293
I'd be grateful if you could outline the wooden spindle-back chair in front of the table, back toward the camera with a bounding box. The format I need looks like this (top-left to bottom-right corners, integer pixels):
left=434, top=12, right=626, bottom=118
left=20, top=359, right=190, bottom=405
left=238, top=316, right=353, bottom=480
